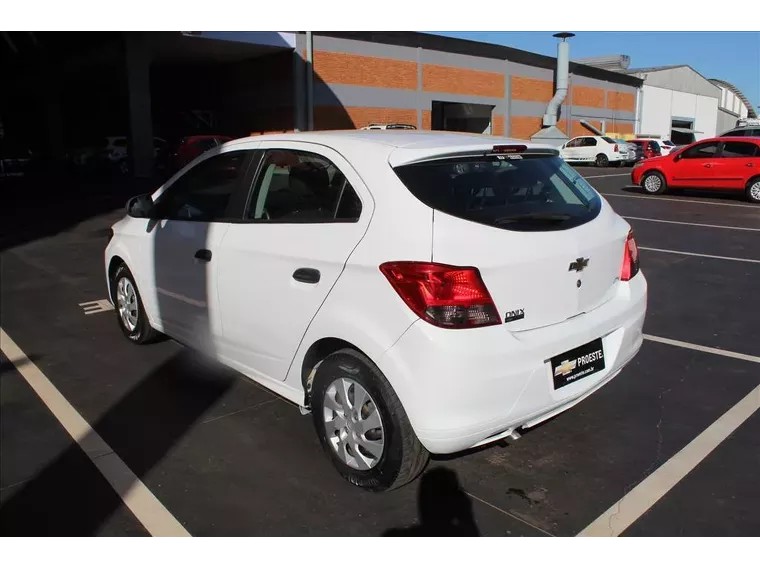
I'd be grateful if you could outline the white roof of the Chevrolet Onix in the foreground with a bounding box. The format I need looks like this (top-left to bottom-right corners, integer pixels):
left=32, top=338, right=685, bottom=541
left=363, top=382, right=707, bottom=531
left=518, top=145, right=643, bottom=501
left=227, top=129, right=556, bottom=167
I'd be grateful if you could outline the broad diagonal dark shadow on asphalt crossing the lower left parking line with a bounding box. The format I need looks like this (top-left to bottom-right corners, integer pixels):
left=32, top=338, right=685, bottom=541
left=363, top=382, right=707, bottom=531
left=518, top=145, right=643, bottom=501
left=0, top=350, right=236, bottom=544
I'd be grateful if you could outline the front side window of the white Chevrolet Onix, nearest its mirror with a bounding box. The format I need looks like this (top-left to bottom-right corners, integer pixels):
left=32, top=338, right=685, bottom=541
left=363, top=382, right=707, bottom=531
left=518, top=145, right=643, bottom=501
left=155, top=150, right=251, bottom=223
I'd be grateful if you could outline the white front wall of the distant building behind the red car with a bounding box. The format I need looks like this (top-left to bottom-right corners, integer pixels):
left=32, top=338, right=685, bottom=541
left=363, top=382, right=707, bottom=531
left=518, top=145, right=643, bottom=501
left=640, top=85, right=720, bottom=140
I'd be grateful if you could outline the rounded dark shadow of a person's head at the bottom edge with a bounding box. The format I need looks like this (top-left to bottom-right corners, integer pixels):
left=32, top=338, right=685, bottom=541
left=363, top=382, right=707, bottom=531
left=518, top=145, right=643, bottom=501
left=378, top=467, right=480, bottom=545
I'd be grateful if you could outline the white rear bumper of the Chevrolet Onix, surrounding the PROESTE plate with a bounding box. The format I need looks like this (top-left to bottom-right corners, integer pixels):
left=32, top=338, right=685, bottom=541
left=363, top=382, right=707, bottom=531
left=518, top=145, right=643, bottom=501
left=379, top=274, right=647, bottom=454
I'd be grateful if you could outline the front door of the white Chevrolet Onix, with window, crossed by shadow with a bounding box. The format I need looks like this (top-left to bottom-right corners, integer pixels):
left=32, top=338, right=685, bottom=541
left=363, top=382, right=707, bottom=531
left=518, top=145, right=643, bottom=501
left=148, top=150, right=253, bottom=349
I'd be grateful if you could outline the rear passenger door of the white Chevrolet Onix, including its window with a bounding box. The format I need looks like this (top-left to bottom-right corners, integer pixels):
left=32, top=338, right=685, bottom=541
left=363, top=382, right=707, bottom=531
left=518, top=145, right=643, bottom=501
left=218, top=142, right=373, bottom=381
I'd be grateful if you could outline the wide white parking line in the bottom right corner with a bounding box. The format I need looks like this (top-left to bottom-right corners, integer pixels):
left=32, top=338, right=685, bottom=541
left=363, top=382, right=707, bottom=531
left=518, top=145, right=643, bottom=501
left=577, top=386, right=760, bottom=541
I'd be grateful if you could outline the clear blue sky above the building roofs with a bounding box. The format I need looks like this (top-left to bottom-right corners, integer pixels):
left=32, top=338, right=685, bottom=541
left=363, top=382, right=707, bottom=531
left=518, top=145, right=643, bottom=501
left=436, top=30, right=760, bottom=110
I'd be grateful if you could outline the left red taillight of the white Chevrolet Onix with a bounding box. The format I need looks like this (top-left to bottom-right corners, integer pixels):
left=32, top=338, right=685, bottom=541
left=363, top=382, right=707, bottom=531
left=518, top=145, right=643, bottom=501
left=380, top=262, right=501, bottom=329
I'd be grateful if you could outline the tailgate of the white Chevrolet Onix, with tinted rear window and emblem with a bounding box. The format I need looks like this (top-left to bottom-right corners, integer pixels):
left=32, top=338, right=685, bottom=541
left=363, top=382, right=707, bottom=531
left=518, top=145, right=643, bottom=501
left=396, top=150, right=629, bottom=331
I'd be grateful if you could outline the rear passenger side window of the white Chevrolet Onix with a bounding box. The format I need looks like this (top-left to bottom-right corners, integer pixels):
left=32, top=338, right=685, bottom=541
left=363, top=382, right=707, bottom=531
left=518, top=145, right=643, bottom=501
left=247, top=150, right=362, bottom=223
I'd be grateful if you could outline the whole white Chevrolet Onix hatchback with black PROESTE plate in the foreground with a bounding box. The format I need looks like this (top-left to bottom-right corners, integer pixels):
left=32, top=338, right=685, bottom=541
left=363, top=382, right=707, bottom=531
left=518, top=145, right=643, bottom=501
left=105, top=131, right=647, bottom=491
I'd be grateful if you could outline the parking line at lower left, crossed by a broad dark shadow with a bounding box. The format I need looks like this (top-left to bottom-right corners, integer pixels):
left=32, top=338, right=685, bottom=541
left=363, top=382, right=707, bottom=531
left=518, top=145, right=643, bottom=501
left=0, top=328, right=193, bottom=544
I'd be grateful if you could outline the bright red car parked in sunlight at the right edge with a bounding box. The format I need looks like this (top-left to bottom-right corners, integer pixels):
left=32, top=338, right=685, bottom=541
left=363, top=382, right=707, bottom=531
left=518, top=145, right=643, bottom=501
left=631, top=137, right=760, bottom=203
